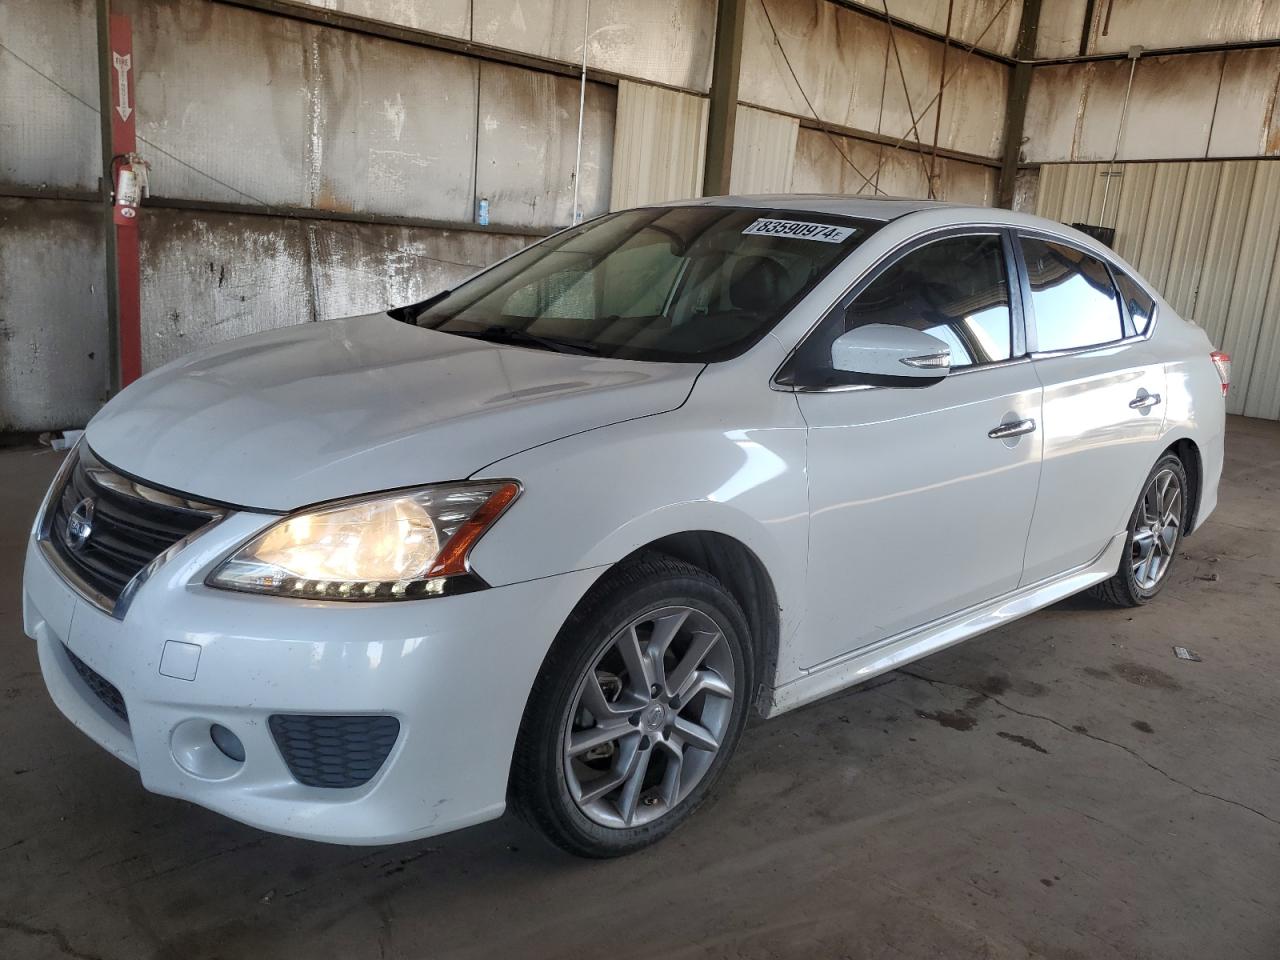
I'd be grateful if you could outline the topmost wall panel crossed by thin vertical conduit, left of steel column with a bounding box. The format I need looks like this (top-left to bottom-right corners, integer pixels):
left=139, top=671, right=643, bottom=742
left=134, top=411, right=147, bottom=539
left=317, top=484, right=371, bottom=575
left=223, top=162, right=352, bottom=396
left=471, top=0, right=716, bottom=93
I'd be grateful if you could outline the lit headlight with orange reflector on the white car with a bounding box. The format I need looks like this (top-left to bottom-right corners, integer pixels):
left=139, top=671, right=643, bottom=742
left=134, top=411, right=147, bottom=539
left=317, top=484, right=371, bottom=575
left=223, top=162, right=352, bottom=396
left=207, top=480, right=520, bottom=600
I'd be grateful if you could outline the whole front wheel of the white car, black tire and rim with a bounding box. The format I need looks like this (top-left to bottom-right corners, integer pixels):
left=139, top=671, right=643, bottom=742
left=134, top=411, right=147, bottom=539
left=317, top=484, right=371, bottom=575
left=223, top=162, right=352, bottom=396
left=511, top=554, right=754, bottom=858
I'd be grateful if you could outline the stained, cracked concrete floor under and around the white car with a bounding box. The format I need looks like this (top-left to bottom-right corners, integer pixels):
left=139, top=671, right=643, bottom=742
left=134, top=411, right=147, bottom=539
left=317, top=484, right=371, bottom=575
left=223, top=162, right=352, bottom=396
left=0, top=419, right=1280, bottom=960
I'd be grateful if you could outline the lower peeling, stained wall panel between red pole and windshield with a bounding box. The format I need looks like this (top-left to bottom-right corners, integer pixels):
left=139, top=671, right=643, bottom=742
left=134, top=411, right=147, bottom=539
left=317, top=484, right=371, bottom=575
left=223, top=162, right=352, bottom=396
left=141, top=209, right=529, bottom=370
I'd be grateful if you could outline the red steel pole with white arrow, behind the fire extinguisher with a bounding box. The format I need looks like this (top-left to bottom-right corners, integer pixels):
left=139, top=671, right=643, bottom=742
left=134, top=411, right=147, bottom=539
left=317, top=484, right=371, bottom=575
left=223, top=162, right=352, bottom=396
left=109, top=13, right=142, bottom=387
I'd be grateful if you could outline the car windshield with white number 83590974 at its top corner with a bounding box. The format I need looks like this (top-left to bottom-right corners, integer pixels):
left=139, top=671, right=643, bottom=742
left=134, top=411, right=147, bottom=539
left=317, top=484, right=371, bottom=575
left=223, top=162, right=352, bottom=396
left=408, top=206, right=881, bottom=362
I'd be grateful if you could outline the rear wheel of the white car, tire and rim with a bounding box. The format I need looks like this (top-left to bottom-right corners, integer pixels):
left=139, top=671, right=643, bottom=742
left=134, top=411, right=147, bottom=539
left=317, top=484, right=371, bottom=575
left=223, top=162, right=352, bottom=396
left=1089, top=453, right=1190, bottom=607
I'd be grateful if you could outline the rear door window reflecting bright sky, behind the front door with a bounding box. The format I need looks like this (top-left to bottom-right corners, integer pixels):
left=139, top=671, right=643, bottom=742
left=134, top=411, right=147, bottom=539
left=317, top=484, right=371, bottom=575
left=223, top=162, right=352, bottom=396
left=1020, top=237, right=1124, bottom=352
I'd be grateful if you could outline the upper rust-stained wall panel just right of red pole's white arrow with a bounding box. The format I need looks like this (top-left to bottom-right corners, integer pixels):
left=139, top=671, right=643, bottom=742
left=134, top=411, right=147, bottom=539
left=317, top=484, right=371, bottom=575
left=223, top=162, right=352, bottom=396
left=134, top=0, right=476, bottom=219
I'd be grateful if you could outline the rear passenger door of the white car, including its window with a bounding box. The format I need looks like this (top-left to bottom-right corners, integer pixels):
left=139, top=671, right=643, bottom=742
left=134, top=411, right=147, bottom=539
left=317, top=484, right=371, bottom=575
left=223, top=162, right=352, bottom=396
left=1018, top=233, right=1165, bottom=585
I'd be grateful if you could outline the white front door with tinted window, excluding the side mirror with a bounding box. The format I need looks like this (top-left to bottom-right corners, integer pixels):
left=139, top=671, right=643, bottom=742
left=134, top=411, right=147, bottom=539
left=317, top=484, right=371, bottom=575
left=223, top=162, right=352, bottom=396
left=790, top=232, right=1042, bottom=669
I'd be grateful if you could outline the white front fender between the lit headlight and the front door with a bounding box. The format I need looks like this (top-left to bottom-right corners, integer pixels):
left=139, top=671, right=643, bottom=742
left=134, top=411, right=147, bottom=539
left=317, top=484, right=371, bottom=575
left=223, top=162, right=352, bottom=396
left=471, top=392, right=809, bottom=647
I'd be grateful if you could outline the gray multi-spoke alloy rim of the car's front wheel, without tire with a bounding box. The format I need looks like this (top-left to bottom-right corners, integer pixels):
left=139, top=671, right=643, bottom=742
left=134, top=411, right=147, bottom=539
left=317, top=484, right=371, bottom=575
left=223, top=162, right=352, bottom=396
left=562, top=605, right=735, bottom=829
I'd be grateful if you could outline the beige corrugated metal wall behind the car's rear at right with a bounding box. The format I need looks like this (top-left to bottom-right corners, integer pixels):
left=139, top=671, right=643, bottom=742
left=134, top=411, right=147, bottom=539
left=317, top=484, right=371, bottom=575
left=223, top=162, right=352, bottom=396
left=1036, top=160, right=1280, bottom=420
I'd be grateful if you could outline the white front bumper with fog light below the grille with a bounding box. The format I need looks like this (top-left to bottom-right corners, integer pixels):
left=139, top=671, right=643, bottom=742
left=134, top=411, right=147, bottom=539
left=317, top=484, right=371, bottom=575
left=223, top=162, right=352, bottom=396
left=23, top=513, right=598, bottom=844
